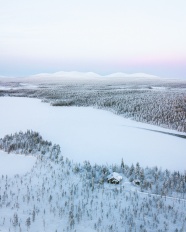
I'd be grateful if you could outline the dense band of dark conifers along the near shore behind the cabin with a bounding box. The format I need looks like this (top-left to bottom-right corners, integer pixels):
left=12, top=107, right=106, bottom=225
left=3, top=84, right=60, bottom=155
left=80, top=159, right=186, bottom=198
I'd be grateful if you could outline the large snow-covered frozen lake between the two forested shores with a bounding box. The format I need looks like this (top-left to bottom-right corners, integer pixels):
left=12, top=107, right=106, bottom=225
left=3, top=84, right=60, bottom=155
left=0, top=97, right=186, bottom=171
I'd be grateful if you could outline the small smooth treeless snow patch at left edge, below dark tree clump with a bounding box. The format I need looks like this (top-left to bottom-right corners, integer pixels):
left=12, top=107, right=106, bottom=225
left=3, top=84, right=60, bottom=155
left=0, top=151, right=36, bottom=176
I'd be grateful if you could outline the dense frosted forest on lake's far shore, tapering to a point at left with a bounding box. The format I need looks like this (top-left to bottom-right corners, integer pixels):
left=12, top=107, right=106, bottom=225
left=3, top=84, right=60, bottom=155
left=52, top=90, right=186, bottom=132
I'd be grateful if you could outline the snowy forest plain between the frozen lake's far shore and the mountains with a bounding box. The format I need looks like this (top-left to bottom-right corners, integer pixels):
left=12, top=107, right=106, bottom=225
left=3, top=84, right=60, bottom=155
left=0, top=80, right=186, bottom=132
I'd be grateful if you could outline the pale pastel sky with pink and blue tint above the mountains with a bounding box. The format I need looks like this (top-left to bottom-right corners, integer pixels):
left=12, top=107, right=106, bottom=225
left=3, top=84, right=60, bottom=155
left=0, top=0, right=186, bottom=78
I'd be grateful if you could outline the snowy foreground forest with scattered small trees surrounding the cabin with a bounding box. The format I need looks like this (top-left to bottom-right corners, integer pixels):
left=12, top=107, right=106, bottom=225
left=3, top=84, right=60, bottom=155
left=0, top=130, right=186, bottom=232
